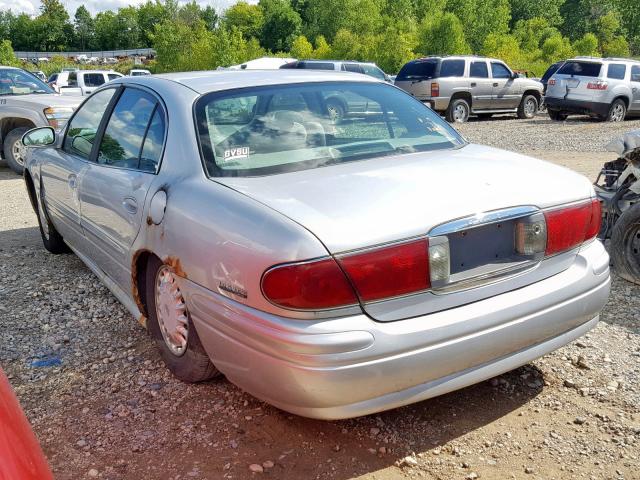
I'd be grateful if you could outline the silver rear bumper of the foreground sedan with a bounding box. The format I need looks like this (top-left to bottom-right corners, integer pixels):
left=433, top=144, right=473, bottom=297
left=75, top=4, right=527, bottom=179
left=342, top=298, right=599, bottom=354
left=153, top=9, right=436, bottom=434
left=181, top=241, right=610, bottom=419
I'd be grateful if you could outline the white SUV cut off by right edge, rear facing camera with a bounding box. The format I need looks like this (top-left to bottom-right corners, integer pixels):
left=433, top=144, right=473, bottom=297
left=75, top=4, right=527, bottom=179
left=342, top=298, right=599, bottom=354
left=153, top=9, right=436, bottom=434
left=545, top=57, right=640, bottom=122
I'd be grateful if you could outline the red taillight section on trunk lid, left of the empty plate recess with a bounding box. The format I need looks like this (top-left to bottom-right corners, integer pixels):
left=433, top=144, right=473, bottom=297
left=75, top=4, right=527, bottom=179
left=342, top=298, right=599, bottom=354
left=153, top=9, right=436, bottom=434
left=338, top=239, right=430, bottom=302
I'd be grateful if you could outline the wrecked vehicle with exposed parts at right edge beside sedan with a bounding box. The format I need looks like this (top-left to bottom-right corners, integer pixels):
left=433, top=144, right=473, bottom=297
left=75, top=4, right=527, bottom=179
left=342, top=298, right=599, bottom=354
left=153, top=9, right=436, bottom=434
left=595, top=130, right=640, bottom=284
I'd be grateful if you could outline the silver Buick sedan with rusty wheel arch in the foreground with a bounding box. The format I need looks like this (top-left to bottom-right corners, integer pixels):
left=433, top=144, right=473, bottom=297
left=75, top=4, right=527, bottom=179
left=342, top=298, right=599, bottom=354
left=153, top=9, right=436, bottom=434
left=23, top=70, right=610, bottom=419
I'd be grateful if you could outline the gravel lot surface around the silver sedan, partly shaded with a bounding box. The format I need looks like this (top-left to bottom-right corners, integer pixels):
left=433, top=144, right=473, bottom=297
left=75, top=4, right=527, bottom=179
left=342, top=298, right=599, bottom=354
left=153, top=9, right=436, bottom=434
left=0, top=114, right=640, bottom=480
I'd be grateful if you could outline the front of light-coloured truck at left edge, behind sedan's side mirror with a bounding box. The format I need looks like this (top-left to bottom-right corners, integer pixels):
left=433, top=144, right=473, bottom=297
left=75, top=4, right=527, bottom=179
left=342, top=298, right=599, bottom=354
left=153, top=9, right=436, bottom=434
left=0, top=66, right=83, bottom=174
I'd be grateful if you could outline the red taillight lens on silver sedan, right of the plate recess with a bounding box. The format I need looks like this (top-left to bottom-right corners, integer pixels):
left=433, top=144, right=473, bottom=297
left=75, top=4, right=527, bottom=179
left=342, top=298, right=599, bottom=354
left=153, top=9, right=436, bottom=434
left=544, top=199, right=601, bottom=255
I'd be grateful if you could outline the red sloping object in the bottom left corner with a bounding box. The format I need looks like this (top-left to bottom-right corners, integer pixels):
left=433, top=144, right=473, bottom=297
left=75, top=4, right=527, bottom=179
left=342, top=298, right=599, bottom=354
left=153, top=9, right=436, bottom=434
left=0, top=369, right=53, bottom=480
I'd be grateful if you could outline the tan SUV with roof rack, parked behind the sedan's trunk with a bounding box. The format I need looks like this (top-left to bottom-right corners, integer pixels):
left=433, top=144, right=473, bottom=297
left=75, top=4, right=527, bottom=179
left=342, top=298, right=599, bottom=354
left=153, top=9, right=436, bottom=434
left=395, top=56, right=543, bottom=122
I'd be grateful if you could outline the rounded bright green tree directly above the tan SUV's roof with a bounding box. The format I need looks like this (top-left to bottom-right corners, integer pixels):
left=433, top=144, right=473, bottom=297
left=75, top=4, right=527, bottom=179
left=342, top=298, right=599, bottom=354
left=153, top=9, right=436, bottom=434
left=417, top=12, right=471, bottom=55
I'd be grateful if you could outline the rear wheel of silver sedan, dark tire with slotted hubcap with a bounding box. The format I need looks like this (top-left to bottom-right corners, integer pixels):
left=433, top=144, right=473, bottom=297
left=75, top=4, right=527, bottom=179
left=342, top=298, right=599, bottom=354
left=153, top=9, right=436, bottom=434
left=145, top=256, right=220, bottom=383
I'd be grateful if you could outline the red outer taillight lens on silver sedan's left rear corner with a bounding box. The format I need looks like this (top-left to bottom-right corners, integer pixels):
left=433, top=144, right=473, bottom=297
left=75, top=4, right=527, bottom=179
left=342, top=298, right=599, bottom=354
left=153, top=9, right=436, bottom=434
left=262, top=258, right=358, bottom=310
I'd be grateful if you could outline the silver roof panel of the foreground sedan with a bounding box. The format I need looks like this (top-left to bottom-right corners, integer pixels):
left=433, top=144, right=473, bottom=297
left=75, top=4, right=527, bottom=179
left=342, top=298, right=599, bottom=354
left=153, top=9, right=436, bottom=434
left=149, top=69, right=382, bottom=93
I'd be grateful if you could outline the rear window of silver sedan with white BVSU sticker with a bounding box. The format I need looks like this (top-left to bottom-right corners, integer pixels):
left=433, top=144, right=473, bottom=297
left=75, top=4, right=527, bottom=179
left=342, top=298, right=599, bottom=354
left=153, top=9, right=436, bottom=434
left=195, top=82, right=464, bottom=176
